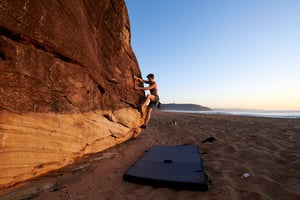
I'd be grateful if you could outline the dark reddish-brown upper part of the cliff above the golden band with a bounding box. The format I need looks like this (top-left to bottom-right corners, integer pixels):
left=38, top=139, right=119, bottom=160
left=0, top=0, right=140, bottom=113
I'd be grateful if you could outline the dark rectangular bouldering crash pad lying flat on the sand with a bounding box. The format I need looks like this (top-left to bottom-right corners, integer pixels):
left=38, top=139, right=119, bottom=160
left=123, top=145, right=207, bottom=191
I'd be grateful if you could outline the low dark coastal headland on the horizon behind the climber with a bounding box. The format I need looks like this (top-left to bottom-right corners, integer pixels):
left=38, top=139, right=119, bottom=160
left=160, top=103, right=212, bottom=111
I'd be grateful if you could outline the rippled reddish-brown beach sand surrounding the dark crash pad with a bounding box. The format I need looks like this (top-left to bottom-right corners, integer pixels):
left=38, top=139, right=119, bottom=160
left=0, top=111, right=300, bottom=200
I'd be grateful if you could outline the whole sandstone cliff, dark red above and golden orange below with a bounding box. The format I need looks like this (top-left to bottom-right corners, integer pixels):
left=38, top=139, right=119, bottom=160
left=0, top=0, right=144, bottom=189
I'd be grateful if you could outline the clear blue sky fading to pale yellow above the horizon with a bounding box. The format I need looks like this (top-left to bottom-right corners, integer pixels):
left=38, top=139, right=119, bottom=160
left=125, top=0, right=300, bottom=110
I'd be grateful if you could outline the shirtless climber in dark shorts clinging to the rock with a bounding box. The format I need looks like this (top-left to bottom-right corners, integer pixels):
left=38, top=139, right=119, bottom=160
left=134, top=74, right=159, bottom=128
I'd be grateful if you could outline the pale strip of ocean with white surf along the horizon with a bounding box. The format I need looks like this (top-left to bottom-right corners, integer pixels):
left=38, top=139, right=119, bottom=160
left=164, top=109, right=300, bottom=119
